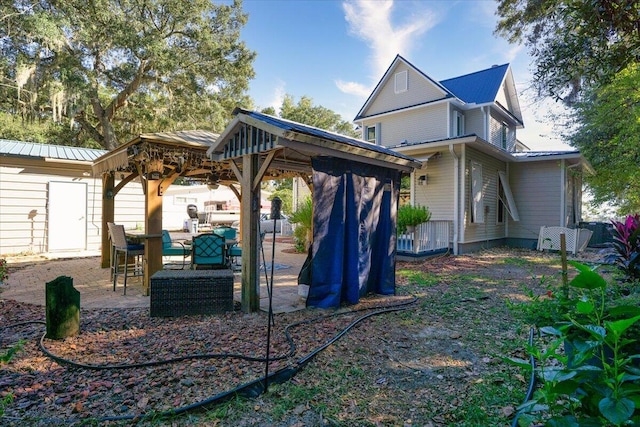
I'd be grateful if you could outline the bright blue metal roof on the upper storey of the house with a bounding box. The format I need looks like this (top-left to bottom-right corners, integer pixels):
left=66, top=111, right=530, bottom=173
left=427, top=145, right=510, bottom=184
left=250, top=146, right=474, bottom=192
left=440, top=64, right=509, bottom=104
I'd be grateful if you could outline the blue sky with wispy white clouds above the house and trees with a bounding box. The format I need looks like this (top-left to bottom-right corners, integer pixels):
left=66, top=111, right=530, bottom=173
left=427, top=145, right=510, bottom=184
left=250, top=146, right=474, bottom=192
left=241, top=0, right=570, bottom=150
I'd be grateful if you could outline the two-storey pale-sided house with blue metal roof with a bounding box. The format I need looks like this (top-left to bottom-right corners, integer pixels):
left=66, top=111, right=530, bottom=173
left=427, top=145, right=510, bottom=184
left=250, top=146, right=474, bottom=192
left=354, top=55, right=590, bottom=254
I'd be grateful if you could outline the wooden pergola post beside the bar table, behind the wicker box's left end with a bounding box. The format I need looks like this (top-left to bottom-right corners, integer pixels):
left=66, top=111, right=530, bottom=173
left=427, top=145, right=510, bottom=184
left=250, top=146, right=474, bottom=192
left=144, top=179, right=162, bottom=295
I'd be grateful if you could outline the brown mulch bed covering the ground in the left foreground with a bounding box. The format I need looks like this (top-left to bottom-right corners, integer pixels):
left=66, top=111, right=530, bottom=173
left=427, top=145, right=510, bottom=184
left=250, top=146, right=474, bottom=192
left=0, top=297, right=411, bottom=425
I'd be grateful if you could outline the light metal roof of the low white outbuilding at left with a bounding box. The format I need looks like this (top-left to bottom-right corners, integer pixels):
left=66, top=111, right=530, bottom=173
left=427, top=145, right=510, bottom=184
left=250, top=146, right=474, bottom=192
left=0, top=139, right=107, bottom=162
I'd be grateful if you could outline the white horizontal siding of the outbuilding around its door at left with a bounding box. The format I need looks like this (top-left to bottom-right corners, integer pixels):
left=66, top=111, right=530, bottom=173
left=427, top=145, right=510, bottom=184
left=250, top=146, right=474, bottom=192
left=0, top=160, right=144, bottom=255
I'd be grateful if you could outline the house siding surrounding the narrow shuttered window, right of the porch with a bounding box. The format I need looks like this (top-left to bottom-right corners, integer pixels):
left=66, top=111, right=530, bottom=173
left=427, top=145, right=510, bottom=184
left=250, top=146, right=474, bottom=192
left=461, top=147, right=508, bottom=243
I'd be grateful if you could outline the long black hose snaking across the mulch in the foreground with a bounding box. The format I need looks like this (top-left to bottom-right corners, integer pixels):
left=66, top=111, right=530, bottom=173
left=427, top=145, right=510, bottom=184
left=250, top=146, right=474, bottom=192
left=0, top=297, right=418, bottom=425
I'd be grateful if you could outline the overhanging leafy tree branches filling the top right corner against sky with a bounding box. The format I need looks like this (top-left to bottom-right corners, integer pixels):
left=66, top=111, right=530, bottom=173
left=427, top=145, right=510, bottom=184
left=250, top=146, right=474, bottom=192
left=495, top=0, right=640, bottom=104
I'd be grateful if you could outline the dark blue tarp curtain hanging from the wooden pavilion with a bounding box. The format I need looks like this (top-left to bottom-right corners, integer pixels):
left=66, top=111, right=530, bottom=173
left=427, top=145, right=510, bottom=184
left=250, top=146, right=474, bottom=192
left=307, top=157, right=400, bottom=308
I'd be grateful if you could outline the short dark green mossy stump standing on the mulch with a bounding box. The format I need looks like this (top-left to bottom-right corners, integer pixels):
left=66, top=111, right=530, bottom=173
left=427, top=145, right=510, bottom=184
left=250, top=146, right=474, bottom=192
left=45, top=276, right=80, bottom=340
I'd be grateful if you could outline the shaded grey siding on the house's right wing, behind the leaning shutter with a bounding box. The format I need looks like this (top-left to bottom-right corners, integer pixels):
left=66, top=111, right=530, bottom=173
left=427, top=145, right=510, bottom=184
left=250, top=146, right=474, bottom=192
left=509, top=161, right=564, bottom=239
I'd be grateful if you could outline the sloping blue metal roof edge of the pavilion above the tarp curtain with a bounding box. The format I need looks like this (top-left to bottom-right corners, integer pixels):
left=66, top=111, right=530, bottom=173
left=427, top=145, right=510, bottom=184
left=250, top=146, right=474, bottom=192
left=233, top=108, right=416, bottom=161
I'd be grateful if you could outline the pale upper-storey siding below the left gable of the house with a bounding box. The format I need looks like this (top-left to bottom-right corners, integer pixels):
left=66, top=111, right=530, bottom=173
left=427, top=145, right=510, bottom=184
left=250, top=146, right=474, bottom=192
left=363, top=104, right=448, bottom=147
